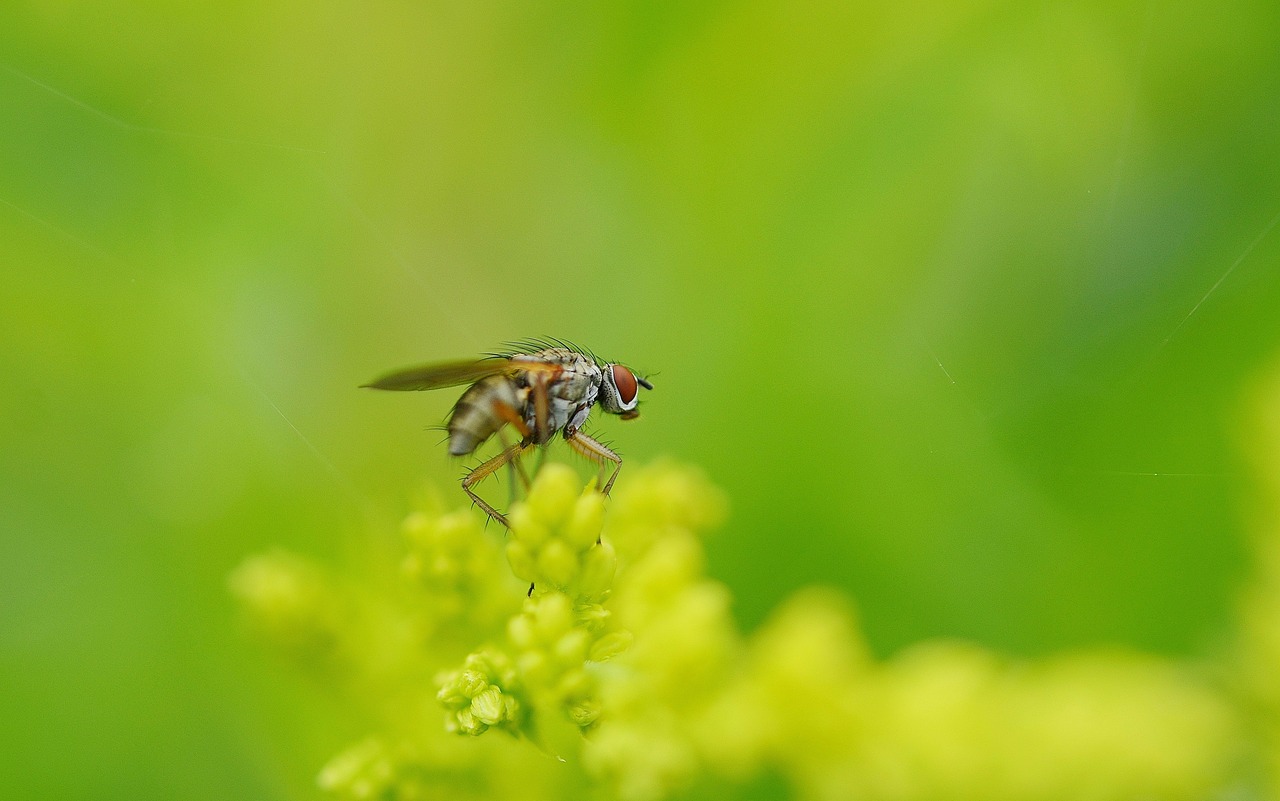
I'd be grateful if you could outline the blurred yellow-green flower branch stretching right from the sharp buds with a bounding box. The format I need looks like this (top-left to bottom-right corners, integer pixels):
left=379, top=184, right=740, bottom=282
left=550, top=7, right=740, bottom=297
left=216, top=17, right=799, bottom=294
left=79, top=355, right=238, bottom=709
left=582, top=511, right=1238, bottom=801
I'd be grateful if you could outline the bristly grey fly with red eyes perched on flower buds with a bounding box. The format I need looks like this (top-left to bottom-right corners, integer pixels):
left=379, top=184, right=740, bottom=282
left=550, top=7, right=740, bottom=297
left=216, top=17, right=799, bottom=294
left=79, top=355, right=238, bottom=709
left=365, top=339, right=653, bottom=528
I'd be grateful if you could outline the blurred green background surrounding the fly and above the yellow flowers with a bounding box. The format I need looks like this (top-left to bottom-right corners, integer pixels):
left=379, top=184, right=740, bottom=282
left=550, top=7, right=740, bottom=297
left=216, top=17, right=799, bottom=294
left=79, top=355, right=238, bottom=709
left=0, top=1, right=1280, bottom=800
